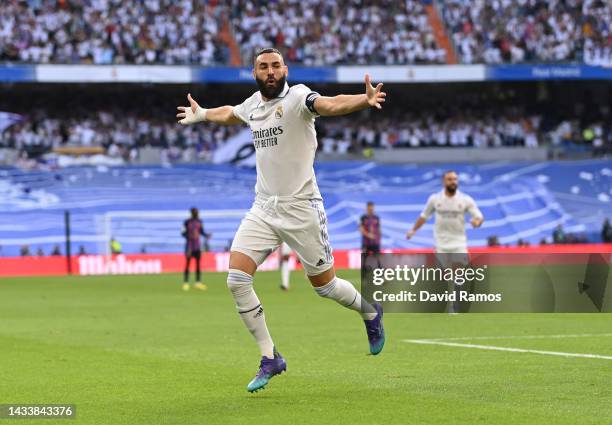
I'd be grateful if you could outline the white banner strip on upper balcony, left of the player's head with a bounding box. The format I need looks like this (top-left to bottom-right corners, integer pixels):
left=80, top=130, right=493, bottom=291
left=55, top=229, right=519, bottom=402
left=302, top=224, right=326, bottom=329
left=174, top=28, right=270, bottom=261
left=36, top=65, right=191, bottom=83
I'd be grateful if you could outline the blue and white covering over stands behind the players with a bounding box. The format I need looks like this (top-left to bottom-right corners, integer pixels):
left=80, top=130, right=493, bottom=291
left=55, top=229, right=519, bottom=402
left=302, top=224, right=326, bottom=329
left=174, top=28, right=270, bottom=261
left=0, top=160, right=612, bottom=255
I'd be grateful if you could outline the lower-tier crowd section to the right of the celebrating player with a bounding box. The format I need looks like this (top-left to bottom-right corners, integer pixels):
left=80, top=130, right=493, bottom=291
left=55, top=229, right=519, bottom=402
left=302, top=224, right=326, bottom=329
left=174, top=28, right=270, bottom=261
left=319, top=110, right=612, bottom=156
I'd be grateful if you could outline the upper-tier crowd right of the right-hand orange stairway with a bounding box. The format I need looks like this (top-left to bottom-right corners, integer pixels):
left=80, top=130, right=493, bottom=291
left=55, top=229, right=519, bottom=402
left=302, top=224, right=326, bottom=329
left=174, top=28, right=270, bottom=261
left=441, top=0, right=612, bottom=66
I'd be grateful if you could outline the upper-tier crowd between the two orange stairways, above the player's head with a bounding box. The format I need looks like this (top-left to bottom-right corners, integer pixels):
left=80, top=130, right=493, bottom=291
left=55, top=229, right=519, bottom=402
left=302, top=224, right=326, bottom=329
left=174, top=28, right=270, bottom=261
left=231, top=0, right=446, bottom=65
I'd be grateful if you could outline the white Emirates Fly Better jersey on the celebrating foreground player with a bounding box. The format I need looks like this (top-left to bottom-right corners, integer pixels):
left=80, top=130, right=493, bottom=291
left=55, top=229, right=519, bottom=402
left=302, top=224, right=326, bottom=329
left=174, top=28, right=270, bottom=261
left=234, top=84, right=321, bottom=199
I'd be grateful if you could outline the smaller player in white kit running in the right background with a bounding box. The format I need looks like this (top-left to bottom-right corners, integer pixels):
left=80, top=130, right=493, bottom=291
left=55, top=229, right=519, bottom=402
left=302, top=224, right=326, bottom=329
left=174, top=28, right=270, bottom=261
left=406, top=171, right=484, bottom=313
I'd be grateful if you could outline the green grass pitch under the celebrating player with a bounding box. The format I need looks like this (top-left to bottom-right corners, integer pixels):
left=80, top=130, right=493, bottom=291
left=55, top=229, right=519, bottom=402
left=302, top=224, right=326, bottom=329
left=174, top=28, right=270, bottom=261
left=0, top=272, right=612, bottom=425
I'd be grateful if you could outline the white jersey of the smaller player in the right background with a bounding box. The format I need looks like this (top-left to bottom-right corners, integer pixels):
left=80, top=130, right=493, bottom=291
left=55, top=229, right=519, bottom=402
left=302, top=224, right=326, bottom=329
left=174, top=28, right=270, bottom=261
left=421, top=190, right=482, bottom=251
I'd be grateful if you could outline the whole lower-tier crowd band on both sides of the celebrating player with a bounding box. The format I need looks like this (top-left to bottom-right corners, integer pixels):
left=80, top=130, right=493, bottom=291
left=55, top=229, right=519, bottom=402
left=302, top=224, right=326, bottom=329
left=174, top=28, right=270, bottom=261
left=0, top=109, right=612, bottom=161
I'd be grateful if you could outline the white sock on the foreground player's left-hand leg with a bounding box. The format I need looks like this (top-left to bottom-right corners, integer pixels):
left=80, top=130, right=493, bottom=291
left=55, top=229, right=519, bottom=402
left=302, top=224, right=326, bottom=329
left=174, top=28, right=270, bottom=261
left=227, top=269, right=274, bottom=359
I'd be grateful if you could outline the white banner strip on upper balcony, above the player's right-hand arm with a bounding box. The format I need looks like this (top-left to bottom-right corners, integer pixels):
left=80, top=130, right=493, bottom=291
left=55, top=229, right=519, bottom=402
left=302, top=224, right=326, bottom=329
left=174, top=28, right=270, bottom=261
left=337, top=65, right=486, bottom=83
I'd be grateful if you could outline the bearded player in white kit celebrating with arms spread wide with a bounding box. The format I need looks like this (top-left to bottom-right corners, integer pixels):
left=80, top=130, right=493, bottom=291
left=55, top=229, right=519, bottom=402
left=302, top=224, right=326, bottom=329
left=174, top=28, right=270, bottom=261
left=177, top=48, right=386, bottom=392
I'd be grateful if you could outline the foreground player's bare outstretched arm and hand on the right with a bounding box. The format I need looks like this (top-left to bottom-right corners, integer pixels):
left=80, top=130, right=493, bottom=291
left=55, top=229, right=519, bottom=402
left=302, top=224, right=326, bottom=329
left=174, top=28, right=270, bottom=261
left=314, top=74, right=387, bottom=116
